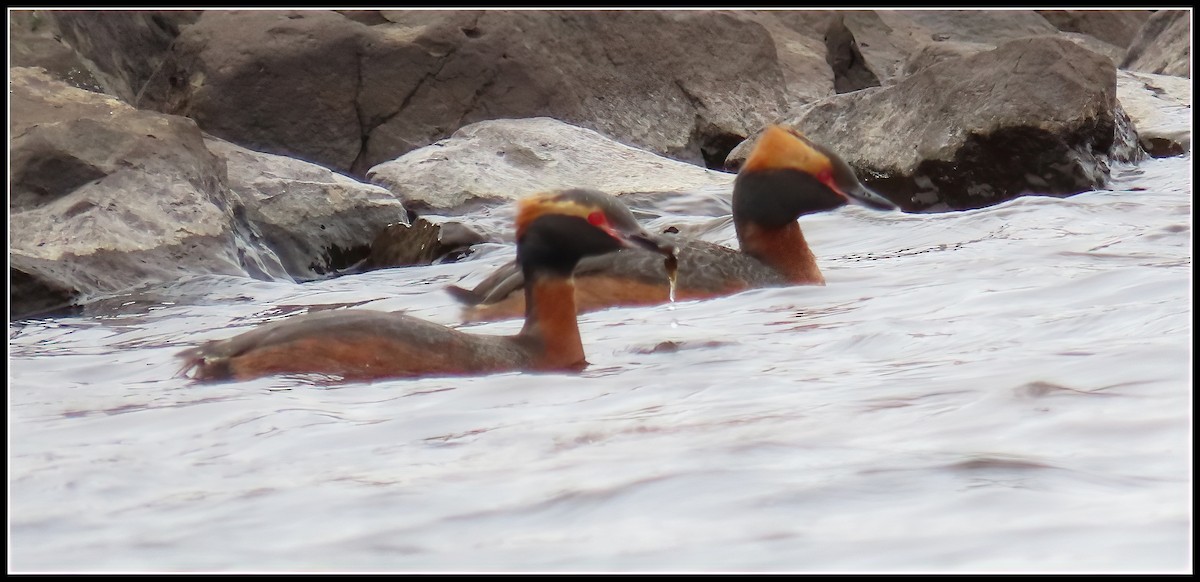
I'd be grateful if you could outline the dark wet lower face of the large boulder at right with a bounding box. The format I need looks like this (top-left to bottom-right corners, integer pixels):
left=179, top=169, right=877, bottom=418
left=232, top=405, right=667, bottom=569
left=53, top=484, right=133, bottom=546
left=859, top=127, right=1111, bottom=212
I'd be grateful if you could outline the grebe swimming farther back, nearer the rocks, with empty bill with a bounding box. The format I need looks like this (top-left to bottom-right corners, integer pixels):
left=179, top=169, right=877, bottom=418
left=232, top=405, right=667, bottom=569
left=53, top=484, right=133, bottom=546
left=448, top=125, right=896, bottom=320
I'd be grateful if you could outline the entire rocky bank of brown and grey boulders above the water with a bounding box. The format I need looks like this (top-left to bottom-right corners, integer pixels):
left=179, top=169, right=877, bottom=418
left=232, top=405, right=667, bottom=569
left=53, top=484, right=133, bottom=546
left=10, top=10, right=1192, bottom=319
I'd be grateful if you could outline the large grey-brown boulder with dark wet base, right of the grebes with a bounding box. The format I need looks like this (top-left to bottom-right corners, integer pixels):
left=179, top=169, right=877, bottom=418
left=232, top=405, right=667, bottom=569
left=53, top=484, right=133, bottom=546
left=728, top=36, right=1144, bottom=210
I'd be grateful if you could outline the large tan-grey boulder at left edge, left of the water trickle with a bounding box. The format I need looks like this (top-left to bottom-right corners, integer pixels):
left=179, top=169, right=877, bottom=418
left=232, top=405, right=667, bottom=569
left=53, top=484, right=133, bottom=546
left=8, top=67, right=282, bottom=316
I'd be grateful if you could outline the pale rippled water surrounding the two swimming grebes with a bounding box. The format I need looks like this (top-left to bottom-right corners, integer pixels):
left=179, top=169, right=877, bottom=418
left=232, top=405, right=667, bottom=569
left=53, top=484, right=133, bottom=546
left=8, top=155, right=1193, bottom=572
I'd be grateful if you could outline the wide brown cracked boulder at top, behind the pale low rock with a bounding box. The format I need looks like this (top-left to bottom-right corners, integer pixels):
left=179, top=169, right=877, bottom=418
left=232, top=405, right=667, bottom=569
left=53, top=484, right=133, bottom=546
left=139, top=11, right=786, bottom=175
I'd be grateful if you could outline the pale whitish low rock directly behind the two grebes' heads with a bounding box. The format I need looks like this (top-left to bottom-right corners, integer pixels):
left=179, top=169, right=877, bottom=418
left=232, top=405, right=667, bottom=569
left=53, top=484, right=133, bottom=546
left=367, top=118, right=733, bottom=214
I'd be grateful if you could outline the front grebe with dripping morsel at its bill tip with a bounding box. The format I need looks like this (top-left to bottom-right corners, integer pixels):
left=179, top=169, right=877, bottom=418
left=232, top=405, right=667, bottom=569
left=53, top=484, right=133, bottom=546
left=179, top=190, right=671, bottom=380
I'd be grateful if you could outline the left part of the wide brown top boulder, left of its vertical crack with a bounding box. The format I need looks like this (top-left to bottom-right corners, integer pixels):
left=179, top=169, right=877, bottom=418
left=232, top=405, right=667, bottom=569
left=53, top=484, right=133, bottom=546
left=138, top=10, right=362, bottom=170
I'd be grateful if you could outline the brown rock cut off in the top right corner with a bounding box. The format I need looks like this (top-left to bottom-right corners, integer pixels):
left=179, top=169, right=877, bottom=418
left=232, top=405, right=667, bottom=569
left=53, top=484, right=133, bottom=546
left=1121, top=10, right=1192, bottom=79
